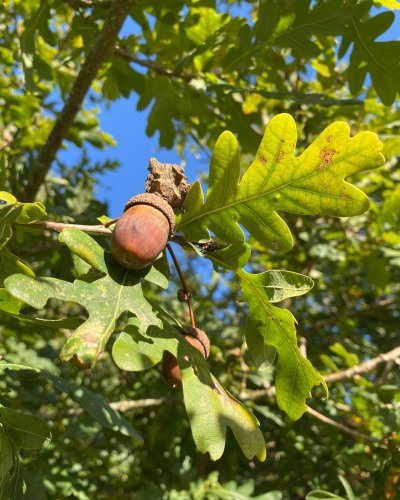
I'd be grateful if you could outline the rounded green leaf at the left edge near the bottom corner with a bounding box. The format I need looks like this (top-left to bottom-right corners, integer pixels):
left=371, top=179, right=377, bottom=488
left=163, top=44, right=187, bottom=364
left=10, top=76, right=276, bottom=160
left=0, top=406, right=51, bottom=450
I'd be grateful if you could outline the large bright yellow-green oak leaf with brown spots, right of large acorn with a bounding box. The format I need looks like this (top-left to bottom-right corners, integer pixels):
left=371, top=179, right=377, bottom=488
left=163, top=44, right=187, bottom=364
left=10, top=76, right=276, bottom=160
left=176, top=113, right=384, bottom=251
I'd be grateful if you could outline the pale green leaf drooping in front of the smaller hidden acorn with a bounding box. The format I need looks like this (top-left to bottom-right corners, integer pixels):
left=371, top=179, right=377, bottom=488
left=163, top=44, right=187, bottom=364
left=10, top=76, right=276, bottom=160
left=112, top=321, right=266, bottom=461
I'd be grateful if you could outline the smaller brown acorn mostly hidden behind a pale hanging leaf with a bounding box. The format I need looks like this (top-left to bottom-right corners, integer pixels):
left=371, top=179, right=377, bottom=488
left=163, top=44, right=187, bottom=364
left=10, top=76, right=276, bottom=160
left=162, top=327, right=210, bottom=389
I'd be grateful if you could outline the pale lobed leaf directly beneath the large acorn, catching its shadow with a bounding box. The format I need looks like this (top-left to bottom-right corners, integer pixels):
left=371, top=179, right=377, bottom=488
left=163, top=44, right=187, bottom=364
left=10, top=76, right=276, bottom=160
left=5, top=229, right=165, bottom=366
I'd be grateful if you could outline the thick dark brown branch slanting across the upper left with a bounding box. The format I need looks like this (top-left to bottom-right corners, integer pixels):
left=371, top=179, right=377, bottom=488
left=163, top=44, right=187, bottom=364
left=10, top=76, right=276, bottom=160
left=23, top=0, right=135, bottom=201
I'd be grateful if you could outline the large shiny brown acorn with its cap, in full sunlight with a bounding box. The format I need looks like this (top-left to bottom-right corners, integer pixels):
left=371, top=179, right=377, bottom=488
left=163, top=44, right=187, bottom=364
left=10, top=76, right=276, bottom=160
left=111, top=193, right=175, bottom=269
